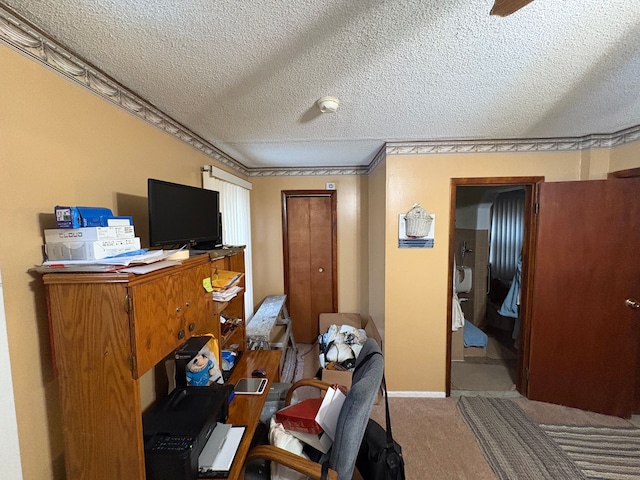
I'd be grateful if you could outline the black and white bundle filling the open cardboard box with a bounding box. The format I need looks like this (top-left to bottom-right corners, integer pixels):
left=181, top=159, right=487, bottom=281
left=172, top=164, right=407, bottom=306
left=318, top=325, right=367, bottom=371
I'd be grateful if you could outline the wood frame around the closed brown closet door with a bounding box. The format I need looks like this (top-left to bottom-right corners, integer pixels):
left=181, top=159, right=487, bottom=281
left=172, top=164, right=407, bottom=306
left=281, top=190, right=338, bottom=312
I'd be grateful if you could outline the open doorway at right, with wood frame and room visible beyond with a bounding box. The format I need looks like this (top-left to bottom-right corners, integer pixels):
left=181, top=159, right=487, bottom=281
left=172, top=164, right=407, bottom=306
left=447, top=177, right=542, bottom=396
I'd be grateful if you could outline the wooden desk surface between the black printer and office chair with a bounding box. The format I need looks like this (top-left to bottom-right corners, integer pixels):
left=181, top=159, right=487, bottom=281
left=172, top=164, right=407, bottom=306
left=218, top=350, right=282, bottom=480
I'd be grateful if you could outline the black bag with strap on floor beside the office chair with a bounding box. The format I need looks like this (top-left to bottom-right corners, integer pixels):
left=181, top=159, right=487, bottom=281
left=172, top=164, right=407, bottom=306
left=356, top=377, right=405, bottom=480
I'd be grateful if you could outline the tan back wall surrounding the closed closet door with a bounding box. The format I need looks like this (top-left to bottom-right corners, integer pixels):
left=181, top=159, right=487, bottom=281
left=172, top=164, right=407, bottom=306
left=251, top=175, right=369, bottom=321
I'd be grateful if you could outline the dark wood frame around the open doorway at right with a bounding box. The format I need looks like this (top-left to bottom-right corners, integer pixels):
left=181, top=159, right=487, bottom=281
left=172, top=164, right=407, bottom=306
left=445, top=176, right=544, bottom=397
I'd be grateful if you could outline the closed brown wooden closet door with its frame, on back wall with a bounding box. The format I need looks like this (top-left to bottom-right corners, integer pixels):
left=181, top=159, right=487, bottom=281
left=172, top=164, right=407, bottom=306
left=282, top=190, right=338, bottom=343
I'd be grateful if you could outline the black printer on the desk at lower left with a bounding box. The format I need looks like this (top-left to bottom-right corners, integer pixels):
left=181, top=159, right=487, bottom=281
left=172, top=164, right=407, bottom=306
left=142, top=384, right=233, bottom=480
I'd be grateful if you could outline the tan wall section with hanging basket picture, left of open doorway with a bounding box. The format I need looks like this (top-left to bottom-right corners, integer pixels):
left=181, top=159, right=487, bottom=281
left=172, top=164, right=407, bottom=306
left=384, top=152, right=581, bottom=392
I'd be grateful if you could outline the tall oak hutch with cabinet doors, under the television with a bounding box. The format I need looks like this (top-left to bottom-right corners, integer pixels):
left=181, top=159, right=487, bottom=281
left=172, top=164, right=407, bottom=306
left=43, top=251, right=246, bottom=480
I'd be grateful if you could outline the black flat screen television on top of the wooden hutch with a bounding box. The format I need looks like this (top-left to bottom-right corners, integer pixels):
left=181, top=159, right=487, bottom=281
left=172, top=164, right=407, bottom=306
left=147, top=178, right=222, bottom=250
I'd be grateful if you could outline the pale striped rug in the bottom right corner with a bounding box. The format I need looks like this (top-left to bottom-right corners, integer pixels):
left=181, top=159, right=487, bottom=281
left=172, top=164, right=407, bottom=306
left=540, top=424, right=640, bottom=480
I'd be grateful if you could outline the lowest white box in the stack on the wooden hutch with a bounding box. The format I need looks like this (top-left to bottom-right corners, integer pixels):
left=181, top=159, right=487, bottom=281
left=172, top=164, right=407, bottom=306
left=44, top=237, right=140, bottom=261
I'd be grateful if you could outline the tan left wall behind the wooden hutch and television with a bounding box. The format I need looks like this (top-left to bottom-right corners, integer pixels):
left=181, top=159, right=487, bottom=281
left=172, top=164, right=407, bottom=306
left=0, top=46, right=245, bottom=480
